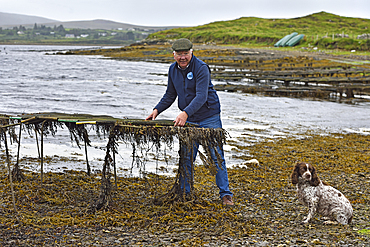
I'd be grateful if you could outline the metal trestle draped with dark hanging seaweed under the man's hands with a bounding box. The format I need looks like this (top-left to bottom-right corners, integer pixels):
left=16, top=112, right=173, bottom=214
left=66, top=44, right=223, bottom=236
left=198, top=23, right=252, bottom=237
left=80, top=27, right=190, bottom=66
left=0, top=113, right=227, bottom=212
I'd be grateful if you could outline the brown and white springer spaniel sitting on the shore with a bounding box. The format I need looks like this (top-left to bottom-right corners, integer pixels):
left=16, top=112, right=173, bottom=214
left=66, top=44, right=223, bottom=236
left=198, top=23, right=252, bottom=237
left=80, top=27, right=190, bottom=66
left=291, top=163, right=353, bottom=225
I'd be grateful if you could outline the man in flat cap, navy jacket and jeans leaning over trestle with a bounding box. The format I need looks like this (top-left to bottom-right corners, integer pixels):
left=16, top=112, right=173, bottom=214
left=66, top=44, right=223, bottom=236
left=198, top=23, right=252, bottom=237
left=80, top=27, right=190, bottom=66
left=146, top=39, right=234, bottom=206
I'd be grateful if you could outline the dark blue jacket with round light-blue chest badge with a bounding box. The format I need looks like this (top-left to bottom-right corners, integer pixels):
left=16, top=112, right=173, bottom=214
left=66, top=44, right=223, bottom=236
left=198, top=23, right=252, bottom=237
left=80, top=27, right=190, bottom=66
left=155, top=55, right=221, bottom=122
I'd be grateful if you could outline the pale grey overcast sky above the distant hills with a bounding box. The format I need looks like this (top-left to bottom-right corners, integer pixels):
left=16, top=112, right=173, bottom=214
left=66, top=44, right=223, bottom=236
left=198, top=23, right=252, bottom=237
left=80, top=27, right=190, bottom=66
left=0, top=0, right=370, bottom=26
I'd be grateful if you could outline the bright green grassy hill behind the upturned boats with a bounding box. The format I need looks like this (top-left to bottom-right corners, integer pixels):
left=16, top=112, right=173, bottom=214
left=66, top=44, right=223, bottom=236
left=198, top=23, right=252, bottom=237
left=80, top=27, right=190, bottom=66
left=148, top=12, right=370, bottom=50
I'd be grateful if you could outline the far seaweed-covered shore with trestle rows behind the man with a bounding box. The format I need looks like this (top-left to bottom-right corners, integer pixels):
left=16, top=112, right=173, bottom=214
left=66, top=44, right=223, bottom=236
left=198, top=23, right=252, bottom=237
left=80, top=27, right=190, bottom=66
left=62, top=43, right=370, bottom=103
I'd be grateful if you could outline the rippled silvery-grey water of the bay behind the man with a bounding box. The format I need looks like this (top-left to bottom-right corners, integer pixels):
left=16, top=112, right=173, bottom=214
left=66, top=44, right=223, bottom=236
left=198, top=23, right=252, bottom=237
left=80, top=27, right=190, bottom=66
left=0, top=46, right=370, bottom=174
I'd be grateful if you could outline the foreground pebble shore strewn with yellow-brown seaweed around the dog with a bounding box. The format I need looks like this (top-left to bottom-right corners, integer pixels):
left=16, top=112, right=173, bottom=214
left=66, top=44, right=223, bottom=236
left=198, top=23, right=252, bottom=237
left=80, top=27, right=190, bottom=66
left=0, top=134, right=370, bottom=246
